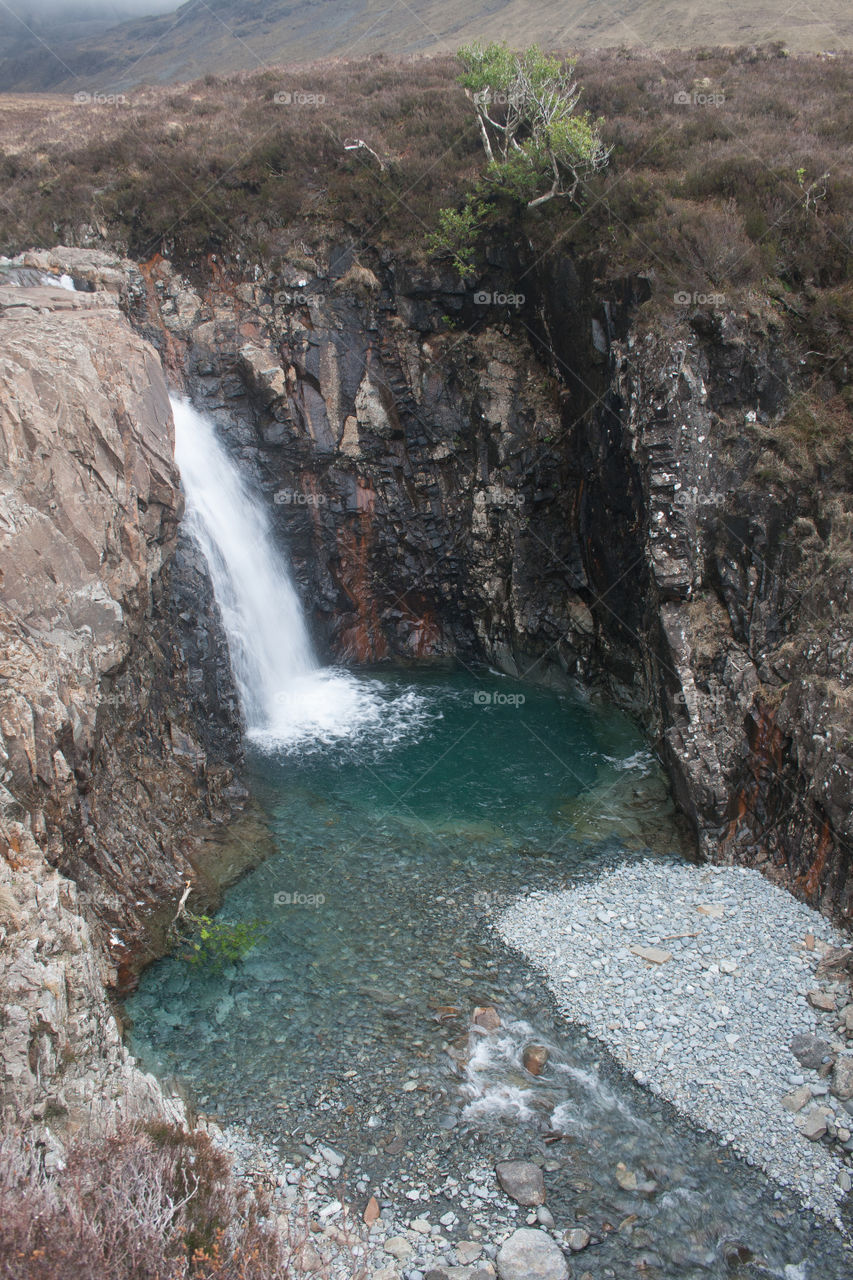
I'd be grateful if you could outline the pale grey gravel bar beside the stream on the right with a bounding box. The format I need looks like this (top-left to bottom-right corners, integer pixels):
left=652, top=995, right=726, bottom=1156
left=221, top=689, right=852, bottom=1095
left=496, top=860, right=853, bottom=1226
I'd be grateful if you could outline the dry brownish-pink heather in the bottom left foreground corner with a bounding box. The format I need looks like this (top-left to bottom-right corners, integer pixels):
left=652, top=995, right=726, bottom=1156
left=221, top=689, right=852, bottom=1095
left=0, top=1125, right=335, bottom=1280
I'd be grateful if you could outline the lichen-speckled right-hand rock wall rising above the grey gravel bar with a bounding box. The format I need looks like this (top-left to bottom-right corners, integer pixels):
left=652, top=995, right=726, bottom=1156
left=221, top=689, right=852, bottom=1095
left=601, top=315, right=853, bottom=920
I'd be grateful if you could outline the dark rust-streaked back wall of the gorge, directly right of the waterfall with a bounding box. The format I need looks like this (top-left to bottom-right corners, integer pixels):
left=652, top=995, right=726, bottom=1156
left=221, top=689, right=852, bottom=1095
left=136, top=256, right=604, bottom=678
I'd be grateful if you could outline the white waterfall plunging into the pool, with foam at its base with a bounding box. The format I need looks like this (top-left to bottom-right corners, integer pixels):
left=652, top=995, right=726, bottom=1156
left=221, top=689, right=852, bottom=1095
left=172, top=396, right=415, bottom=749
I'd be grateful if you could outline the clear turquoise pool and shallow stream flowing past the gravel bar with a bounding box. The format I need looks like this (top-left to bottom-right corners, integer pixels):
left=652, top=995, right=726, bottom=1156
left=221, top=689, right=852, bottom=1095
left=128, top=673, right=849, bottom=1280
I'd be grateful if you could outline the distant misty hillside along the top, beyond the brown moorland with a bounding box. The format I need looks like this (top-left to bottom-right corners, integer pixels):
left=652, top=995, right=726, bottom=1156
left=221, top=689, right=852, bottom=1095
left=0, top=0, right=853, bottom=92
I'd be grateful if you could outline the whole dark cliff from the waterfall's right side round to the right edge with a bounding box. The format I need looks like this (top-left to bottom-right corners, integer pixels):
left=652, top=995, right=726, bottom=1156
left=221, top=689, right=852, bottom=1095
left=73, top=246, right=853, bottom=922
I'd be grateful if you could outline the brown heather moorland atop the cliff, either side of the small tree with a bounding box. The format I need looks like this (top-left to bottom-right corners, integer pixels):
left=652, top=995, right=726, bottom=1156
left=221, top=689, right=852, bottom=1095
left=0, top=49, right=853, bottom=307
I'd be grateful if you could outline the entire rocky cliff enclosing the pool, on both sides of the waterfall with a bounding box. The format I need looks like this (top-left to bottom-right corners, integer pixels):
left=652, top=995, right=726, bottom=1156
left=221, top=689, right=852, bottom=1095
left=0, top=232, right=853, bottom=1162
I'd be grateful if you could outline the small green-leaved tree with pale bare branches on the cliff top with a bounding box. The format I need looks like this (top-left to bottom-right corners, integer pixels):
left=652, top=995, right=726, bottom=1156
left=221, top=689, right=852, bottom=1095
left=459, top=44, right=611, bottom=209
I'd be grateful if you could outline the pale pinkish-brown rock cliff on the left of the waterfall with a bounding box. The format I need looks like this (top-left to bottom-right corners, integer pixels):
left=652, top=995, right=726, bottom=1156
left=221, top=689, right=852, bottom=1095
left=0, top=277, right=240, bottom=1142
